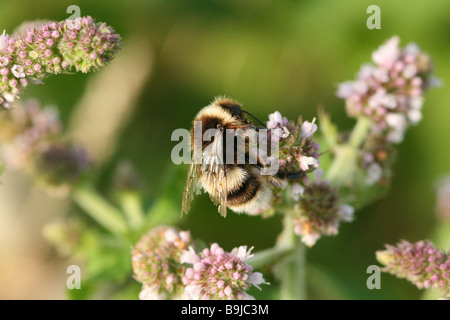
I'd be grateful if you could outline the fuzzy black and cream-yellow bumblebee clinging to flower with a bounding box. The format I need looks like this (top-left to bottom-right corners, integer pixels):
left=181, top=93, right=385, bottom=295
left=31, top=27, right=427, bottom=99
left=181, top=97, right=301, bottom=217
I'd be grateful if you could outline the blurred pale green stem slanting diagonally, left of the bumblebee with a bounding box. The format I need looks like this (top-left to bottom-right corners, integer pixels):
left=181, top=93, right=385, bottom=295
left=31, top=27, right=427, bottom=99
left=73, top=188, right=128, bottom=236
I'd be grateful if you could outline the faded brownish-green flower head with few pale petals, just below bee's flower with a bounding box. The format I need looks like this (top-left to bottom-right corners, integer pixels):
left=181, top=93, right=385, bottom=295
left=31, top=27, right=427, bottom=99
left=293, top=170, right=354, bottom=247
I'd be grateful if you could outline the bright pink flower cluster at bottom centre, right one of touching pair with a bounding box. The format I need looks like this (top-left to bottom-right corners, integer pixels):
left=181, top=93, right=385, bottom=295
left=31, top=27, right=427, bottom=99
left=181, top=243, right=265, bottom=300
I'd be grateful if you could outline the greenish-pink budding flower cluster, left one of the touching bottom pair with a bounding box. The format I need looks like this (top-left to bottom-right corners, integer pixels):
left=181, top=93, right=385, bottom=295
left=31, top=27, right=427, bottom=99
left=131, top=227, right=191, bottom=300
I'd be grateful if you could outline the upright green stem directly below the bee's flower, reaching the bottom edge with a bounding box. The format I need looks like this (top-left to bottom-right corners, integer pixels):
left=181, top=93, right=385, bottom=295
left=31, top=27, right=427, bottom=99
left=275, top=213, right=306, bottom=300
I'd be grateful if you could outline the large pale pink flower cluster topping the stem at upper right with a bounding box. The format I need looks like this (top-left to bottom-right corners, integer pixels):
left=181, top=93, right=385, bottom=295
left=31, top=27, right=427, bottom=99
left=337, top=37, right=436, bottom=143
